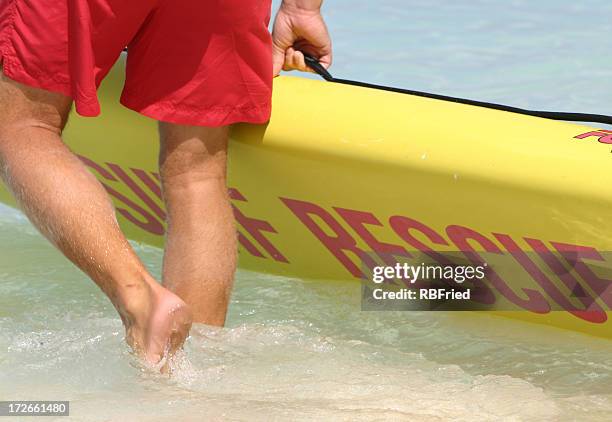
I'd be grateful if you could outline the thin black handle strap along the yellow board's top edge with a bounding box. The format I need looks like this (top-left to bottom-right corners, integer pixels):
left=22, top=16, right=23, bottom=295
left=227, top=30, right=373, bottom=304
left=304, top=54, right=612, bottom=125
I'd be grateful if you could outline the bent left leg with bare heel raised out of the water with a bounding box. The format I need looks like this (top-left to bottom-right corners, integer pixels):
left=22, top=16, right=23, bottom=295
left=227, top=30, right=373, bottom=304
left=0, top=73, right=191, bottom=362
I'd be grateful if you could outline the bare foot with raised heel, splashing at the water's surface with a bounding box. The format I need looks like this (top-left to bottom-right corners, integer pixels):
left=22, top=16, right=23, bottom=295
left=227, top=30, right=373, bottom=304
left=123, top=282, right=192, bottom=364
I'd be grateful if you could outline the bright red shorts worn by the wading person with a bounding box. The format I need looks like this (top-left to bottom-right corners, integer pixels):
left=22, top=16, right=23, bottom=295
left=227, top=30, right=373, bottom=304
left=0, top=0, right=272, bottom=126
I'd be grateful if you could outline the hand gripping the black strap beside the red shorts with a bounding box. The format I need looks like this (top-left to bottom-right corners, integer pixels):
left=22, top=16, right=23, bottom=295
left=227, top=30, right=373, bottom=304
left=272, top=0, right=332, bottom=76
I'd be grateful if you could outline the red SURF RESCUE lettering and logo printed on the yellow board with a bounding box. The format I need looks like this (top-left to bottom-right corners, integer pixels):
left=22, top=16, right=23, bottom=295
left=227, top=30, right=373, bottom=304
left=80, top=155, right=612, bottom=323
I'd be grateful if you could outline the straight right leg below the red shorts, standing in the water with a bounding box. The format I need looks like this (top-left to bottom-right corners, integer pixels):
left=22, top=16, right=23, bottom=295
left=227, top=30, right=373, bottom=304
left=159, top=123, right=237, bottom=325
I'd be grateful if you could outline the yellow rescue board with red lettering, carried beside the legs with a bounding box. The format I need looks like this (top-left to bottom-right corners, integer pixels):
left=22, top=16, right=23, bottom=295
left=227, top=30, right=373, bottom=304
left=0, top=58, right=612, bottom=338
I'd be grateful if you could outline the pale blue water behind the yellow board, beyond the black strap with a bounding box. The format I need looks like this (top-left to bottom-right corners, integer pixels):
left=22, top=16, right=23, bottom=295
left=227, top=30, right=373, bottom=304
left=318, top=0, right=612, bottom=120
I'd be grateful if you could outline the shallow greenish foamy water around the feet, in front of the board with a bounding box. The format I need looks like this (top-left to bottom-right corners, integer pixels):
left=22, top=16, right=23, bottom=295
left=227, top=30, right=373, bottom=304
left=0, top=207, right=612, bottom=421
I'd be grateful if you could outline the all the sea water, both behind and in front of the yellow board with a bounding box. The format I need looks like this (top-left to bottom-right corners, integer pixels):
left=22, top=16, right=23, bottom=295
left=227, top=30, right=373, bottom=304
left=0, top=0, right=612, bottom=421
